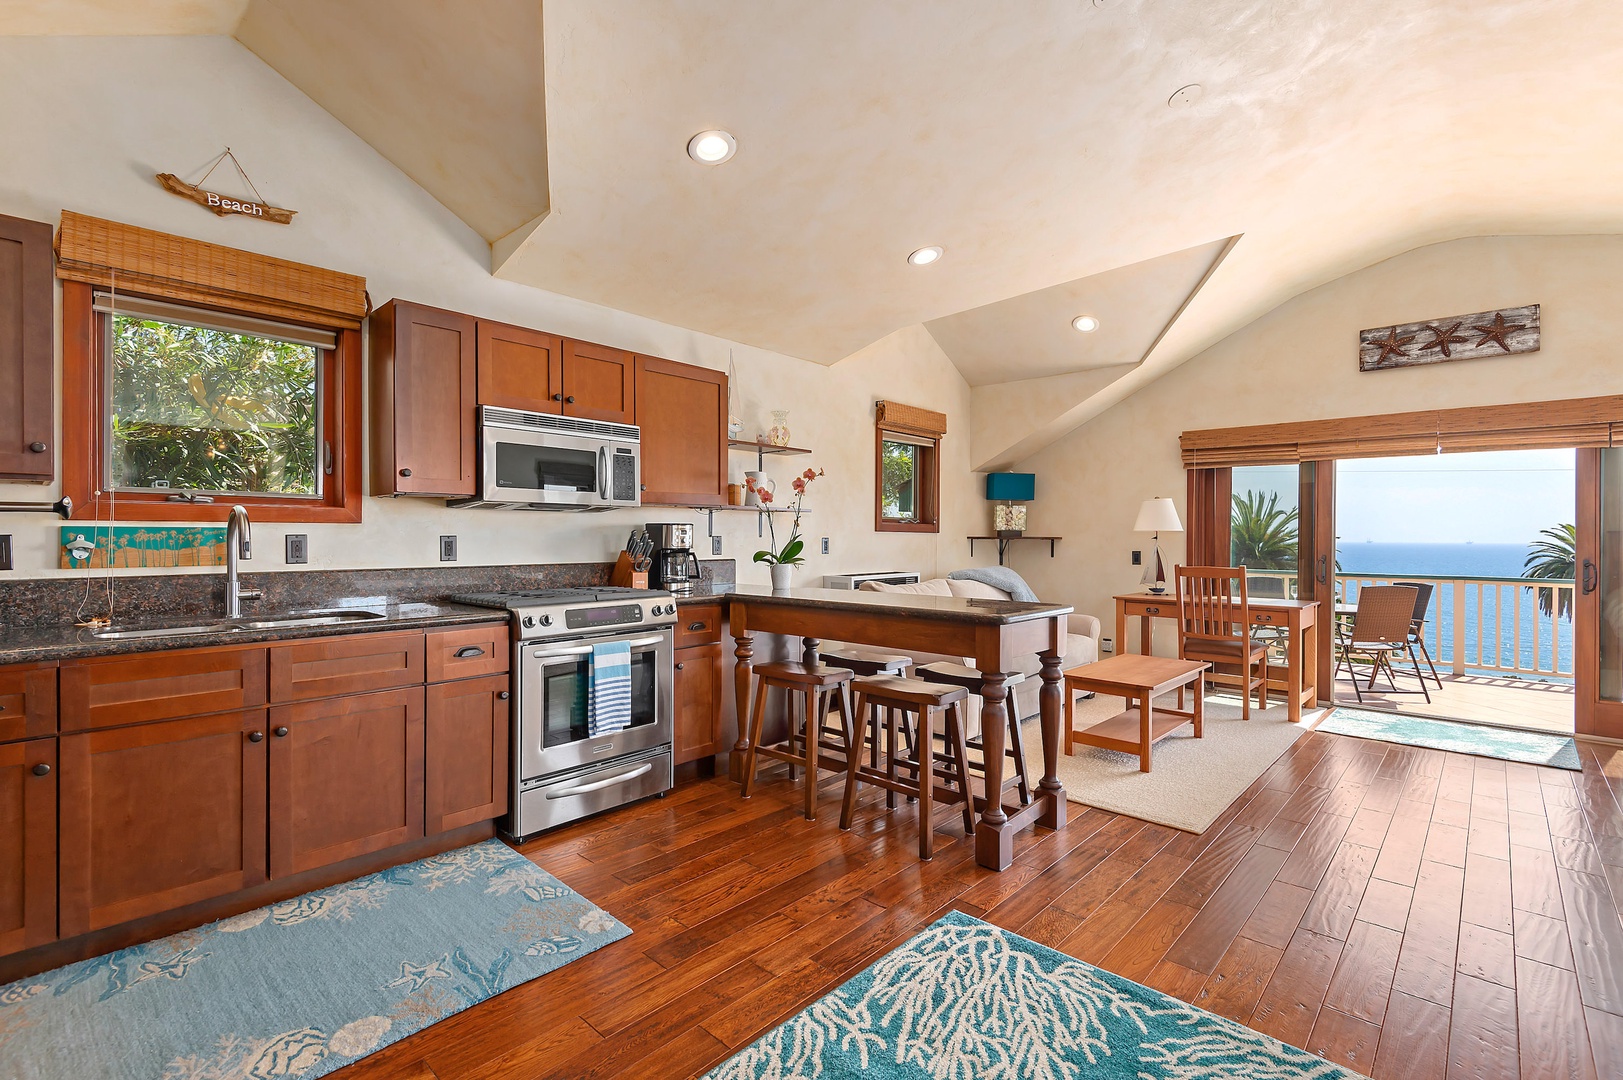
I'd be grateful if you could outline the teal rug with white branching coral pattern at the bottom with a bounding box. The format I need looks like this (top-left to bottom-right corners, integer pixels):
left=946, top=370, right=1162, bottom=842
left=708, top=911, right=1357, bottom=1080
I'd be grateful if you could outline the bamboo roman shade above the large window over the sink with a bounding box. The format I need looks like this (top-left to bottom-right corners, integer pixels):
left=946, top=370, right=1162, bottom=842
left=57, top=210, right=367, bottom=330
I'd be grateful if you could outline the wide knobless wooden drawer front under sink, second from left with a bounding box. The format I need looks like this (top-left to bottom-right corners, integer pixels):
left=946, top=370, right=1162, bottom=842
left=60, top=648, right=265, bottom=731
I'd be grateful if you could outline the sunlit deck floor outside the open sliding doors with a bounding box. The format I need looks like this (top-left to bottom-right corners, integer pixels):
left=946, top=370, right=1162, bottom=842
left=1336, top=672, right=1574, bottom=736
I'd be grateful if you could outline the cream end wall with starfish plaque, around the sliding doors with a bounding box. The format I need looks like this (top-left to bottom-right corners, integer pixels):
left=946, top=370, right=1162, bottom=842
left=1014, top=235, right=1623, bottom=649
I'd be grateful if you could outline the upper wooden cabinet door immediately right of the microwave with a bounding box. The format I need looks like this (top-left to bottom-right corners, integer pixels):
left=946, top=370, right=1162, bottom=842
left=636, top=356, right=727, bottom=507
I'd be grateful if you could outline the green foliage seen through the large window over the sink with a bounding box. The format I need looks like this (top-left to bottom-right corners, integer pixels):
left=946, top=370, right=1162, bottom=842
left=109, top=315, right=318, bottom=495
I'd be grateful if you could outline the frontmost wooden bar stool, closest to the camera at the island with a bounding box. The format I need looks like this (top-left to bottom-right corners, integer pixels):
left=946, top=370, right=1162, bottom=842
left=839, top=676, right=974, bottom=861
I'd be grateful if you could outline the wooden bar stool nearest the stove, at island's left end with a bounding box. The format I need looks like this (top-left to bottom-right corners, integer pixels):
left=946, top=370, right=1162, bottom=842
left=743, top=661, right=857, bottom=822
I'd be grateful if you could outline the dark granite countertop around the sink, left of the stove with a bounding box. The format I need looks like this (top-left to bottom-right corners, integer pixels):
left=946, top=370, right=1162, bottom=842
left=0, top=596, right=508, bottom=664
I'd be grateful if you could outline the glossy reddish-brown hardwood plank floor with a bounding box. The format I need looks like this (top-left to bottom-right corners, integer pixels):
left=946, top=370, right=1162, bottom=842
left=336, top=732, right=1623, bottom=1080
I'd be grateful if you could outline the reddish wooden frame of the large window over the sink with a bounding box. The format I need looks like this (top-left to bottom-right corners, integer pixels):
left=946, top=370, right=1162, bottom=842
left=62, top=281, right=364, bottom=523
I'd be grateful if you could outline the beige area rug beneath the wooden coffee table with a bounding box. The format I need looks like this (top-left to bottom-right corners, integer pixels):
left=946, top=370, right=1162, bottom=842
left=1024, top=695, right=1324, bottom=833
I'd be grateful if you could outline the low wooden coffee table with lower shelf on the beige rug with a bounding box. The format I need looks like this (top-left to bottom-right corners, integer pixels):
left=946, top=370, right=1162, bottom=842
left=1065, top=653, right=1209, bottom=773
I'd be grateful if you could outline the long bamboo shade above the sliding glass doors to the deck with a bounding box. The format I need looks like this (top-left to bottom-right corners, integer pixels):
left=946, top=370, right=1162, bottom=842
left=1178, top=396, right=1623, bottom=469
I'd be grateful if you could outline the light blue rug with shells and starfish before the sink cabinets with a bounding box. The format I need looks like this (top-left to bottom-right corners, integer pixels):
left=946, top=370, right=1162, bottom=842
left=0, top=840, right=631, bottom=1080
